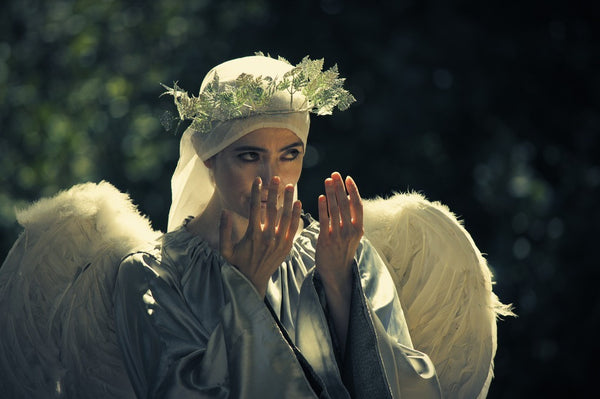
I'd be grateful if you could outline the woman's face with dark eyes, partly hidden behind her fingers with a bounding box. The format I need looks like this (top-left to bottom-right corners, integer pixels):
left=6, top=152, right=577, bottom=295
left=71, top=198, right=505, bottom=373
left=205, top=128, right=304, bottom=218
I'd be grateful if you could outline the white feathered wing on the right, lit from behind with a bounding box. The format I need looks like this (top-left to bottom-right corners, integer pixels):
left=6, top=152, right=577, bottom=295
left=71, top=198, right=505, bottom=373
left=364, top=194, right=512, bottom=398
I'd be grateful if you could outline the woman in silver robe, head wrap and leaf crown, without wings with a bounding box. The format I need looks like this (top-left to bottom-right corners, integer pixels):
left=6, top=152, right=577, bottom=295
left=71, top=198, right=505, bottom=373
left=115, top=55, right=440, bottom=398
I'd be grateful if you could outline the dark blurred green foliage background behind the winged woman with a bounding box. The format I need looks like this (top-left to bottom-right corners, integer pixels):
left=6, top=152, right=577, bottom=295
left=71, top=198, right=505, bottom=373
left=0, top=0, right=600, bottom=398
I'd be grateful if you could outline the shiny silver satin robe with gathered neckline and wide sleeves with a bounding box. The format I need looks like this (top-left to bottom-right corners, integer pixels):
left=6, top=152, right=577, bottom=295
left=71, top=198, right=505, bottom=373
left=114, top=223, right=439, bottom=398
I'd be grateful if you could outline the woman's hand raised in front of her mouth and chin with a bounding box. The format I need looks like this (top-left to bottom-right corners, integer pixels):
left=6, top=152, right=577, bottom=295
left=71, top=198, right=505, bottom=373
left=219, top=176, right=302, bottom=297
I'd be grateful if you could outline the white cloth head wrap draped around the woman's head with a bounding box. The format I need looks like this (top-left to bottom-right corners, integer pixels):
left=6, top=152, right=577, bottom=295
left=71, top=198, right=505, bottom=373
left=167, top=56, right=310, bottom=231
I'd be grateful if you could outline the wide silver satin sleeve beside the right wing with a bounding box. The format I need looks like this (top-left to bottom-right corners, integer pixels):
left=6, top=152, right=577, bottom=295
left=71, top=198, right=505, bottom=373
left=296, top=240, right=441, bottom=398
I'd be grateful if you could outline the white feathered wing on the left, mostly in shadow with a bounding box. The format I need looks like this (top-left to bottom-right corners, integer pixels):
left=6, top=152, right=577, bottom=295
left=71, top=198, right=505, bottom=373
left=0, top=182, right=157, bottom=398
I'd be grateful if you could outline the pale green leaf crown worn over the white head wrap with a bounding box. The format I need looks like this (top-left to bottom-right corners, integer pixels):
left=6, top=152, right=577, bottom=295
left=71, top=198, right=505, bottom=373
left=161, top=52, right=356, bottom=133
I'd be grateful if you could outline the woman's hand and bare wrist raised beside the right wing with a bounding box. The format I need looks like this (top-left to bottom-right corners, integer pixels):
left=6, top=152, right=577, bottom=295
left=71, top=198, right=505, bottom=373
left=315, top=172, right=364, bottom=353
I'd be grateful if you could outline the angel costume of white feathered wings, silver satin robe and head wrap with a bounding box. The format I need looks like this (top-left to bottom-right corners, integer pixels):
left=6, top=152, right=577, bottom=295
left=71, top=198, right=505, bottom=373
left=0, top=56, right=510, bottom=398
